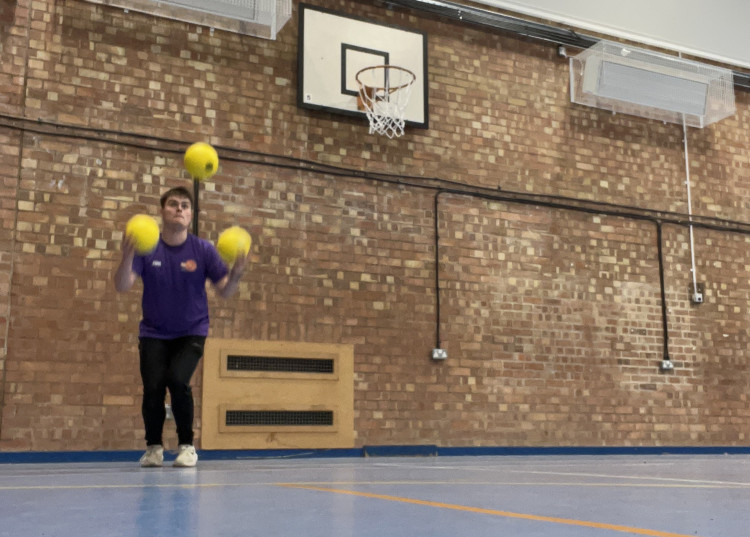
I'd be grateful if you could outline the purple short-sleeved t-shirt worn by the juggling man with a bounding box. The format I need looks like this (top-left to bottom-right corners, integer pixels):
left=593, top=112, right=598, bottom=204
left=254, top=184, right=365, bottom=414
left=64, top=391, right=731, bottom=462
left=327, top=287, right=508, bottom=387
left=133, top=234, right=229, bottom=339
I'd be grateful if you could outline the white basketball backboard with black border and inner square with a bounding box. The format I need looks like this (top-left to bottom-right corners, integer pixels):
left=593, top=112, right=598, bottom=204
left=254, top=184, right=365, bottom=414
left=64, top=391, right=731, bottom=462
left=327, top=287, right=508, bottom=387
left=297, top=4, right=428, bottom=129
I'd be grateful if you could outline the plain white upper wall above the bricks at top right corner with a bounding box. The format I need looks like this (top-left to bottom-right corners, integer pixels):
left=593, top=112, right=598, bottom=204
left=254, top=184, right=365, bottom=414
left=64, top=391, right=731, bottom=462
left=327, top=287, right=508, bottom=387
left=475, top=0, right=750, bottom=68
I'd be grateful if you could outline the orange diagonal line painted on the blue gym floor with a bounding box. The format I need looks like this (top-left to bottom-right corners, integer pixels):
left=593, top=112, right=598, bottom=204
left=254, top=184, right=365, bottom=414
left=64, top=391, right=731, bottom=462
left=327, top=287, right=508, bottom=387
left=279, top=483, right=696, bottom=537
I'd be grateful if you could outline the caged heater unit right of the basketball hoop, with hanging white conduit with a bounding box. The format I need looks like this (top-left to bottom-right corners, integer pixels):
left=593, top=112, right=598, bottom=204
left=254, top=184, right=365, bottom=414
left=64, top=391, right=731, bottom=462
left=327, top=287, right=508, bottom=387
left=570, top=41, right=735, bottom=128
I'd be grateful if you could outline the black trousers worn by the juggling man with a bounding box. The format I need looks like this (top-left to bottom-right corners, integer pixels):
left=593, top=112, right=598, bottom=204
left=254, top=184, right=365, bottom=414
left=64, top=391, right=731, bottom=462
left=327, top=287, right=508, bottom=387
left=138, top=336, right=206, bottom=446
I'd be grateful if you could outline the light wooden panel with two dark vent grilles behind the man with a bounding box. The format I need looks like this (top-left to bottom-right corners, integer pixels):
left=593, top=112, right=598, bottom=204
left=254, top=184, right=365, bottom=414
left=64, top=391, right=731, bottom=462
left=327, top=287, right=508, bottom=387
left=201, top=338, right=354, bottom=449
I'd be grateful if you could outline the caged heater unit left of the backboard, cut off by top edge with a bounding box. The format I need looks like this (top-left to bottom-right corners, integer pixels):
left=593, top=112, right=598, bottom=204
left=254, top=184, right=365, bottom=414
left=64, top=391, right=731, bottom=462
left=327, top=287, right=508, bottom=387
left=88, top=0, right=292, bottom=39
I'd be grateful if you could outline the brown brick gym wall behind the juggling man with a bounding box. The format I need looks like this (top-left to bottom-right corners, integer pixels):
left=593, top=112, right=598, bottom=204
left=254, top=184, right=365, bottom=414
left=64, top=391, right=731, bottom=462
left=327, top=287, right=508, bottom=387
left=0, top=0, right=750, bottom=450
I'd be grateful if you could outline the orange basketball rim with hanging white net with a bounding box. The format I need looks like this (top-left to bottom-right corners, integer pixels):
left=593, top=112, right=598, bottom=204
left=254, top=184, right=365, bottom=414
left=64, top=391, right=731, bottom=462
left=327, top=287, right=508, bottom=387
left=354, top=65, right=417, bottom=138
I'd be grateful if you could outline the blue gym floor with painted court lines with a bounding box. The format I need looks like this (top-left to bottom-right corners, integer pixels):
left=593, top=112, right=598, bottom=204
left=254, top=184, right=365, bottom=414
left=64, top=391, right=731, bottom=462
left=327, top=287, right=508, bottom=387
left=0, top=455, right=750, bottom=537
